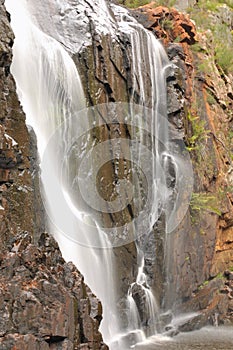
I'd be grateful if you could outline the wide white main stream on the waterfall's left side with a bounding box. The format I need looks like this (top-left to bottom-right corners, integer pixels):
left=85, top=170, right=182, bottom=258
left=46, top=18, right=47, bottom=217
left=6, top=0, right=120, bottom=344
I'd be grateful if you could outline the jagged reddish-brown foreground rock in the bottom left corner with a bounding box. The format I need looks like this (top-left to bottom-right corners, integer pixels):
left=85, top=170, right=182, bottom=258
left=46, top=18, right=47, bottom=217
left=0, top=232, right=107, bottom=350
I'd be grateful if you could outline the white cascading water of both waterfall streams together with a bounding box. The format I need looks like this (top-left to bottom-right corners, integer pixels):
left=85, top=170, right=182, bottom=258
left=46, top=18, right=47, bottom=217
left=6, top=0, right=193, bottom=350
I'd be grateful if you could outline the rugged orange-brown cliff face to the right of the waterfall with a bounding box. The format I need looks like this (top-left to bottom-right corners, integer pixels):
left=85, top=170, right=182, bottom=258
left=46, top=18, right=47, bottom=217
left=133, top=1, right=233, bottom=327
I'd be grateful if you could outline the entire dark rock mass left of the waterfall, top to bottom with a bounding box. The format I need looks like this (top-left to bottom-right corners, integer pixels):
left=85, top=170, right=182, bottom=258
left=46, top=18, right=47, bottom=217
left=0, top=0, right=107, bottom=350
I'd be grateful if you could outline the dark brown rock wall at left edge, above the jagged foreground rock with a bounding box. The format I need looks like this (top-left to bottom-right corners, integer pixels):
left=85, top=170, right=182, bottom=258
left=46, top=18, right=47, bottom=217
left=0, top=1, right=34, bottom=251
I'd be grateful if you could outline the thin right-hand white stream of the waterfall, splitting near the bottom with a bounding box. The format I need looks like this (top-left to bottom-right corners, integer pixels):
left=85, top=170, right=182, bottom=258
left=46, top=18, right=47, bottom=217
left=113, top=7, right=169, bottom=341
